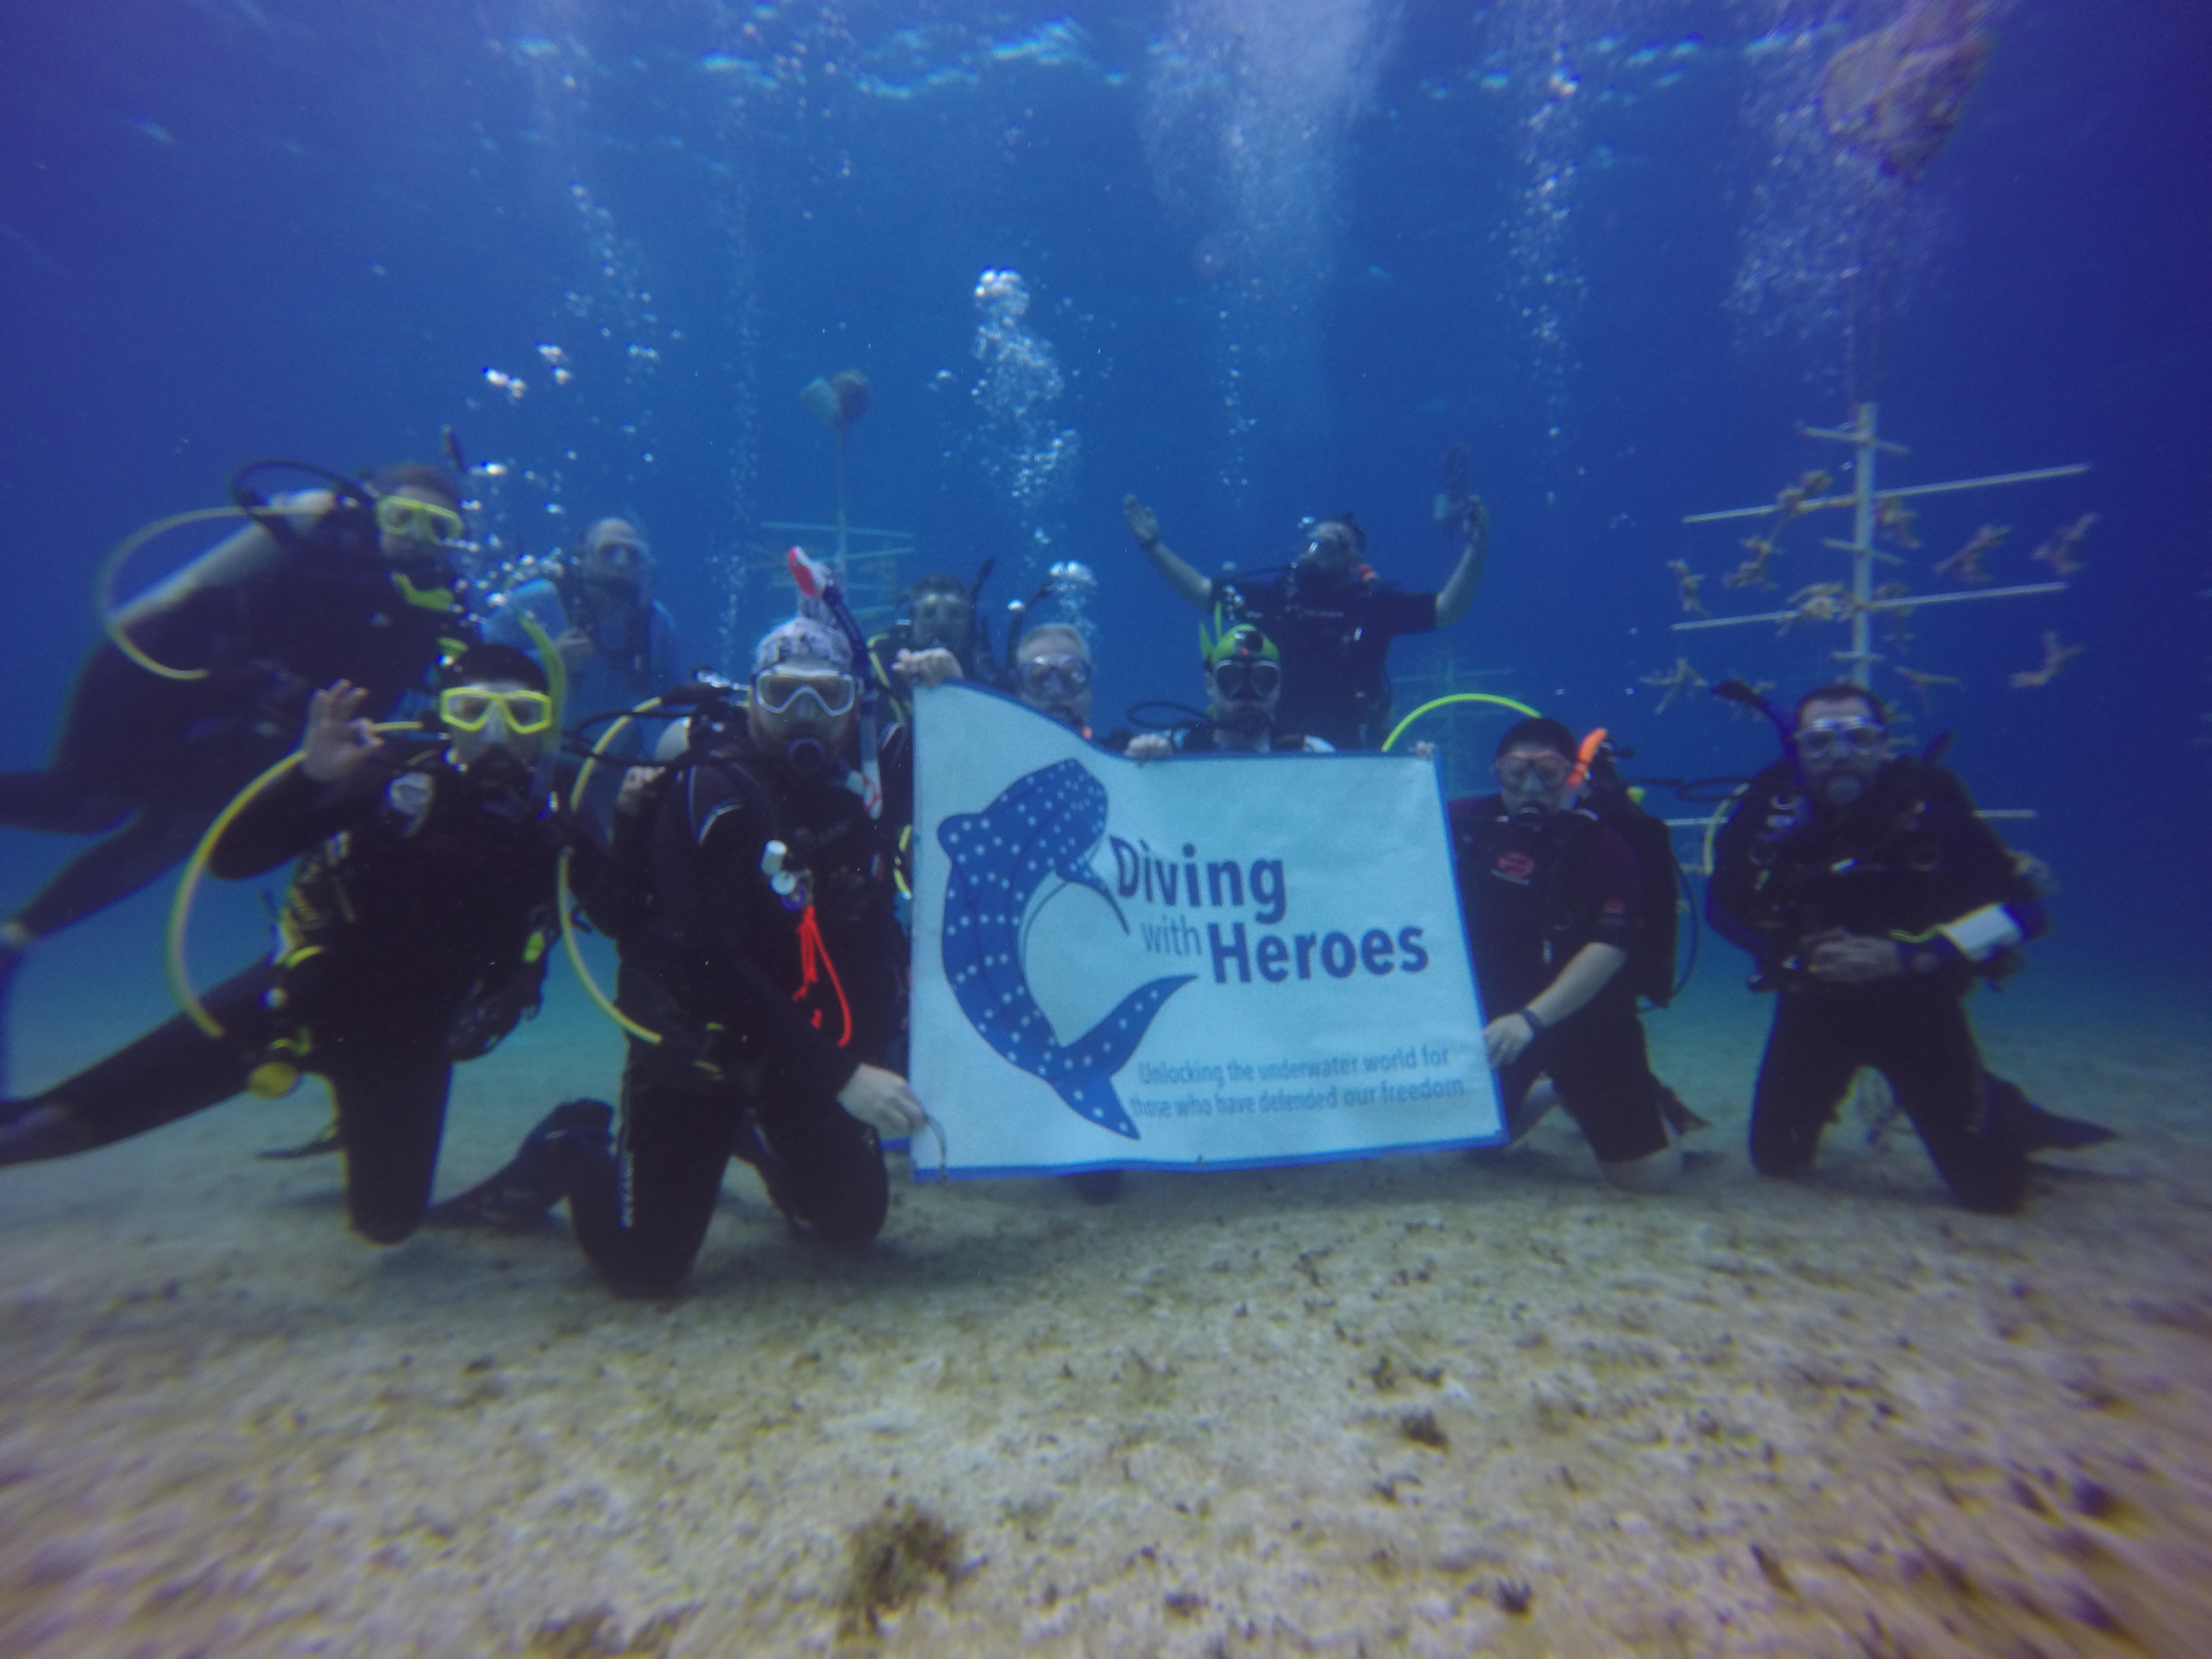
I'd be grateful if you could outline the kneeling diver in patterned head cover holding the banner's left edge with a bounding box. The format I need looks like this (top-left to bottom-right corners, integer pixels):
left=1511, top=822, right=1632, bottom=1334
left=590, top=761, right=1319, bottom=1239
left=434, top=617, right=929, bottom=1296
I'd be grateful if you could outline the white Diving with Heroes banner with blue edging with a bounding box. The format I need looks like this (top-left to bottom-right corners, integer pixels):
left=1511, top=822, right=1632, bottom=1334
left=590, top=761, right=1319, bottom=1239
left=914, top=681, right=1504, bottom=1179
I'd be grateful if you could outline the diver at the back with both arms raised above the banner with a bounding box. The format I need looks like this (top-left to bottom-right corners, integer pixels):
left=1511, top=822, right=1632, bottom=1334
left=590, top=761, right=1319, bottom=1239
left=1121, top=449, right=1491, bottom=750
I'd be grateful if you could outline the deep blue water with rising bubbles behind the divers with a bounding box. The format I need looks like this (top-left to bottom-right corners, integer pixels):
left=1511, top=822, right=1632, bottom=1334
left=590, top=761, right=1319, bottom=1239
left=0, top=0, right=2212, bottom=1053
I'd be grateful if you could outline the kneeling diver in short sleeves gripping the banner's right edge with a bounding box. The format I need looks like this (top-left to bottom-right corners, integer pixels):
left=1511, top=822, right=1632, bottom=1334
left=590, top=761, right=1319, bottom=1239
left=1451, top=717, right=1701, bottom=1192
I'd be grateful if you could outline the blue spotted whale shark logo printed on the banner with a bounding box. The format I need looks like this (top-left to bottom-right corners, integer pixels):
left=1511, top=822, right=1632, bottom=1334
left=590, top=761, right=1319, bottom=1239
left=938, top=761, right=1197, bottom=1141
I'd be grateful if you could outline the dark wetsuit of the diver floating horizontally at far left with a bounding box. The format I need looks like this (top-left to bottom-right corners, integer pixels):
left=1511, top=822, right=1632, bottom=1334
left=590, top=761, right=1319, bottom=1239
left=0, top=520, right=462, bottom=938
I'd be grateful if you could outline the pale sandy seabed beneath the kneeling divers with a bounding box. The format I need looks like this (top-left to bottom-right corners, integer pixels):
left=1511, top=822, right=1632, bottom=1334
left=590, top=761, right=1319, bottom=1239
left=0, top=989, right=2212, bottom=1659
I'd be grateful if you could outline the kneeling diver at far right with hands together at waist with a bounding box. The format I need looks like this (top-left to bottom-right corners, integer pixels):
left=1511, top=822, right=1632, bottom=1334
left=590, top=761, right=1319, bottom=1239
left=1705, top=681, right=2112, bottom=1214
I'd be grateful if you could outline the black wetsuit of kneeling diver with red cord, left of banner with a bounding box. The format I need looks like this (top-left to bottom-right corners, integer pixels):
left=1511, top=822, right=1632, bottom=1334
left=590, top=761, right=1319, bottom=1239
left=564, top=723, right=907, bottom=1296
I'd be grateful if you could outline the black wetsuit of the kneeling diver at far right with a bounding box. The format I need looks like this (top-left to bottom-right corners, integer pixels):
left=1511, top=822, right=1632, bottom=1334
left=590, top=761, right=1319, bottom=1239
left=1705, top=761, right=2039, bottom=1212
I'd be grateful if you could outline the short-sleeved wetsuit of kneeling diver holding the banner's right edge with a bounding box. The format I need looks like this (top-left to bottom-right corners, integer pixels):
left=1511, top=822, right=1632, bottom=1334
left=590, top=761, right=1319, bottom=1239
left=1451, top=794, right=1672, bottom=1164
